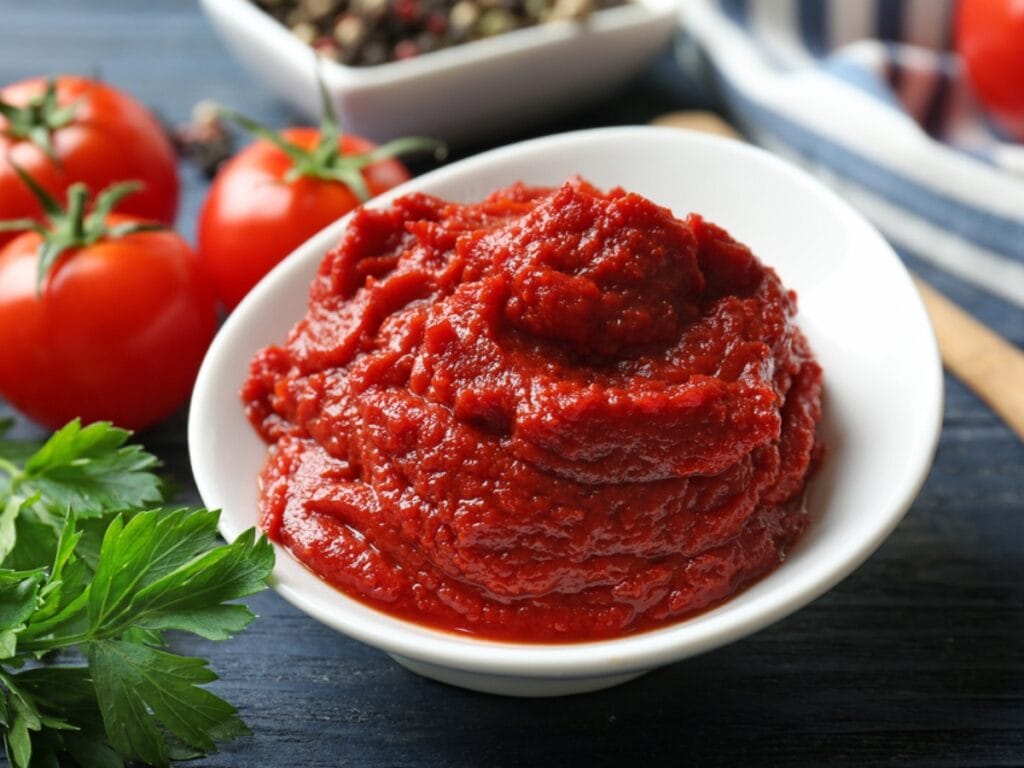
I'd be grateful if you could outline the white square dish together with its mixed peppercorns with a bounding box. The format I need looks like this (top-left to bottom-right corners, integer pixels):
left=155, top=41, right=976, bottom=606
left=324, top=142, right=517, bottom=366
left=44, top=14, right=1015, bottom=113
left=200, top=0, right=679, bottom=144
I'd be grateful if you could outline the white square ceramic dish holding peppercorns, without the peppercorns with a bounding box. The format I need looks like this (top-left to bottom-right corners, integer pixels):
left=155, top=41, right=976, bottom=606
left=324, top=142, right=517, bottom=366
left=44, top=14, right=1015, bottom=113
left=200, top=0, right=678, bottom=143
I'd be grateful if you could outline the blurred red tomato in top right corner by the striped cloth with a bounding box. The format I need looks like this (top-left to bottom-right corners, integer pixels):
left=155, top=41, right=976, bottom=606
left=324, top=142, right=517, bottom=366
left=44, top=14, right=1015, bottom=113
left=956, top=0, right=1024, bottom=141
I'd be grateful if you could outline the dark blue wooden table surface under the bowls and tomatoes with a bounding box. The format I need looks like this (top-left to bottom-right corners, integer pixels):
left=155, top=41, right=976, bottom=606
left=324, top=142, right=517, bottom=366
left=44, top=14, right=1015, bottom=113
left=0, top=0, right=1024, bottom=768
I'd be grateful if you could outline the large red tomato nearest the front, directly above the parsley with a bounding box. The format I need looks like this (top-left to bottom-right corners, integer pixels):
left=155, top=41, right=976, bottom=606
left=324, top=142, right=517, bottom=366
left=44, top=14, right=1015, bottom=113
left=0, top=214, right=216, bottom=429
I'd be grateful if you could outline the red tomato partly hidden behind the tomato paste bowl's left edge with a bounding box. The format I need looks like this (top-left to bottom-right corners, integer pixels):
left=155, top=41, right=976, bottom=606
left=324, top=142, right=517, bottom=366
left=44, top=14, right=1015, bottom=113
left=199, top=128, right=410, bottom=309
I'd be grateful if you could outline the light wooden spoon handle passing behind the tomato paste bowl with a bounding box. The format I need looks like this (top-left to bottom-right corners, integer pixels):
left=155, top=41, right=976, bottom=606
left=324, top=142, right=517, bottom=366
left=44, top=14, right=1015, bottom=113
left=651, top=112, right=1024, bottom=440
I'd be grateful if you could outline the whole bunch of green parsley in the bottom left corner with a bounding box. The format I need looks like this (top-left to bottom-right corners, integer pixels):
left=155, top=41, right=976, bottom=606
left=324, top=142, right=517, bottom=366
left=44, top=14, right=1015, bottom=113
left=0, top=420, right=273, bottom=768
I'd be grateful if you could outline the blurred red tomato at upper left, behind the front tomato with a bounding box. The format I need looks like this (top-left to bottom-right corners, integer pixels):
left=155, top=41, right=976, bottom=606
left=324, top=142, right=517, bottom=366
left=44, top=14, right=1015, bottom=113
left=0, top=76, right=178, bottom=245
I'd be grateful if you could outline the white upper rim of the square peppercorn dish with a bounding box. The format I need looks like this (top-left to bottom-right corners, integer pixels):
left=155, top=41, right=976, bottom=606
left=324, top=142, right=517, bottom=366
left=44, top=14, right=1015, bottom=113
left=200, top=0, right=680, bottom=88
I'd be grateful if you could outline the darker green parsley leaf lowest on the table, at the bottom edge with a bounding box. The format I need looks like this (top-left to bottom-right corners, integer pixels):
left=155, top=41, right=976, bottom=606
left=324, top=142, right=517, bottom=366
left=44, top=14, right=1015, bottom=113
left=89, top=640, right=248, bottom=766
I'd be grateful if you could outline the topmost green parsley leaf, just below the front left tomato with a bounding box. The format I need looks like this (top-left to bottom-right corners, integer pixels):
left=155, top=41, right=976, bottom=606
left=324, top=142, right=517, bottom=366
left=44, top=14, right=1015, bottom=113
left=15, top=420, right=163, bottom=517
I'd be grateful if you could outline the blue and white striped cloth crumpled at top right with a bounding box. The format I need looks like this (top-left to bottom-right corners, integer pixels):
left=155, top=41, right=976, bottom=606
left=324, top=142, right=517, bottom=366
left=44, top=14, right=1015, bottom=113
left=679, top=0, right=1024, bottom=308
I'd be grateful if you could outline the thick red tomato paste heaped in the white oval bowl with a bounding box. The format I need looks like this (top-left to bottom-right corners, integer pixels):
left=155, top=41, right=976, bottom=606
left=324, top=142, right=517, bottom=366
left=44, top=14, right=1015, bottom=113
left=243, top=179, right=821, bottom=642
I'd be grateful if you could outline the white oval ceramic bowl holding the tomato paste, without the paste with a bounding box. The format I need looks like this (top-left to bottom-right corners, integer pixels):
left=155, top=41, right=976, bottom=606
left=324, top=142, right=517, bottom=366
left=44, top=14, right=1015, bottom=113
left=188, top=128, right=942, bottom=695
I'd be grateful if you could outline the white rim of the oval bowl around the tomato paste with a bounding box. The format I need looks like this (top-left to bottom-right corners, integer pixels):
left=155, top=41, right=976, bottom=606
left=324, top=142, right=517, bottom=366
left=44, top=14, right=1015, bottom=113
left=188, top=126, right=943, bottom=679
